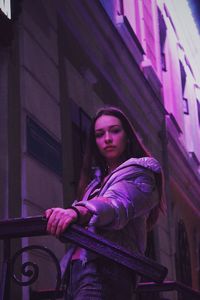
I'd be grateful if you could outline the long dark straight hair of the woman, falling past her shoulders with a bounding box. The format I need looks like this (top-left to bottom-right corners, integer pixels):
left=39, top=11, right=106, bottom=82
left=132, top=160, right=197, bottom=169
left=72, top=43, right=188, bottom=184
left=77, top=106, right=162, bottom=228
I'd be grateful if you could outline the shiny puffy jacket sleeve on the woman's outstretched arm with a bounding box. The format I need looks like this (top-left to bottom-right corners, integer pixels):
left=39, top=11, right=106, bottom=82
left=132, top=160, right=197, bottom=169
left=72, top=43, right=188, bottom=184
left=75, top=170, right=159, bottom=229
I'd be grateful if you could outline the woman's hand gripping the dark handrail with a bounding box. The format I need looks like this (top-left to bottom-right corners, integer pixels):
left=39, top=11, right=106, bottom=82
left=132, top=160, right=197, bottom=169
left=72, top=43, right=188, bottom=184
left=45, top=207, right=77, bottom=237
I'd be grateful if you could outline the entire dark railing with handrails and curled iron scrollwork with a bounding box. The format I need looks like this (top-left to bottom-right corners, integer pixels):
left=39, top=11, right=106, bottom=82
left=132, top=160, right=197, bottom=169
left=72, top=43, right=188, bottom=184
left=0, top=216, right=200, bottom=300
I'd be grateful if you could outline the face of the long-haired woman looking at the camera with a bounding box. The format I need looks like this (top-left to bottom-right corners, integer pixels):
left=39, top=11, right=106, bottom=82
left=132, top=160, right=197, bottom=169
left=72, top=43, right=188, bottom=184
left=94, top=115, right=127, bottom=165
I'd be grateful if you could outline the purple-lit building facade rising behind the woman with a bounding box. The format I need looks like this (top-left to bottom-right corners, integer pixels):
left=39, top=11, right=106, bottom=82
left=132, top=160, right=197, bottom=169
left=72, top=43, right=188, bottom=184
left=0, top=0, right=200, bottom=300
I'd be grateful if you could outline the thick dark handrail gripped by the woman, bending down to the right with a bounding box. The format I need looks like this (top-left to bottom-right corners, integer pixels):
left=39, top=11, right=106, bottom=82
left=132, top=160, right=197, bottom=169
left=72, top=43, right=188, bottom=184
left=0, top=216, right=167, bottom=282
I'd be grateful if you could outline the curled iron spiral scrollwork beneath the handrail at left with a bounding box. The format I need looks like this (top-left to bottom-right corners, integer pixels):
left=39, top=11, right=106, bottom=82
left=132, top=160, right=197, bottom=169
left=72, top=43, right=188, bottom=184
left=11, top=245, right=61, bottom=291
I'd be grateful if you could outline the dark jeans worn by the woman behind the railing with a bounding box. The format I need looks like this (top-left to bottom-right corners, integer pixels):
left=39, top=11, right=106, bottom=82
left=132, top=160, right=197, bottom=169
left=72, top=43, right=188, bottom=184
left=65, top=258, right=136, bottom=300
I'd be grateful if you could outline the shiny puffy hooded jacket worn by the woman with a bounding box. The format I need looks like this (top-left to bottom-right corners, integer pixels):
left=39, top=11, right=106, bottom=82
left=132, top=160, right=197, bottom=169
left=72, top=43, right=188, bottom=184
left=61, top=157, right=161, bottom=271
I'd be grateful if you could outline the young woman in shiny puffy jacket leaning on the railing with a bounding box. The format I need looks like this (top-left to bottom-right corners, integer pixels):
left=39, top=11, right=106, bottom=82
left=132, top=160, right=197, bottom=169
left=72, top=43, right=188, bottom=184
left=46, top=107, right=162, bottom=300
